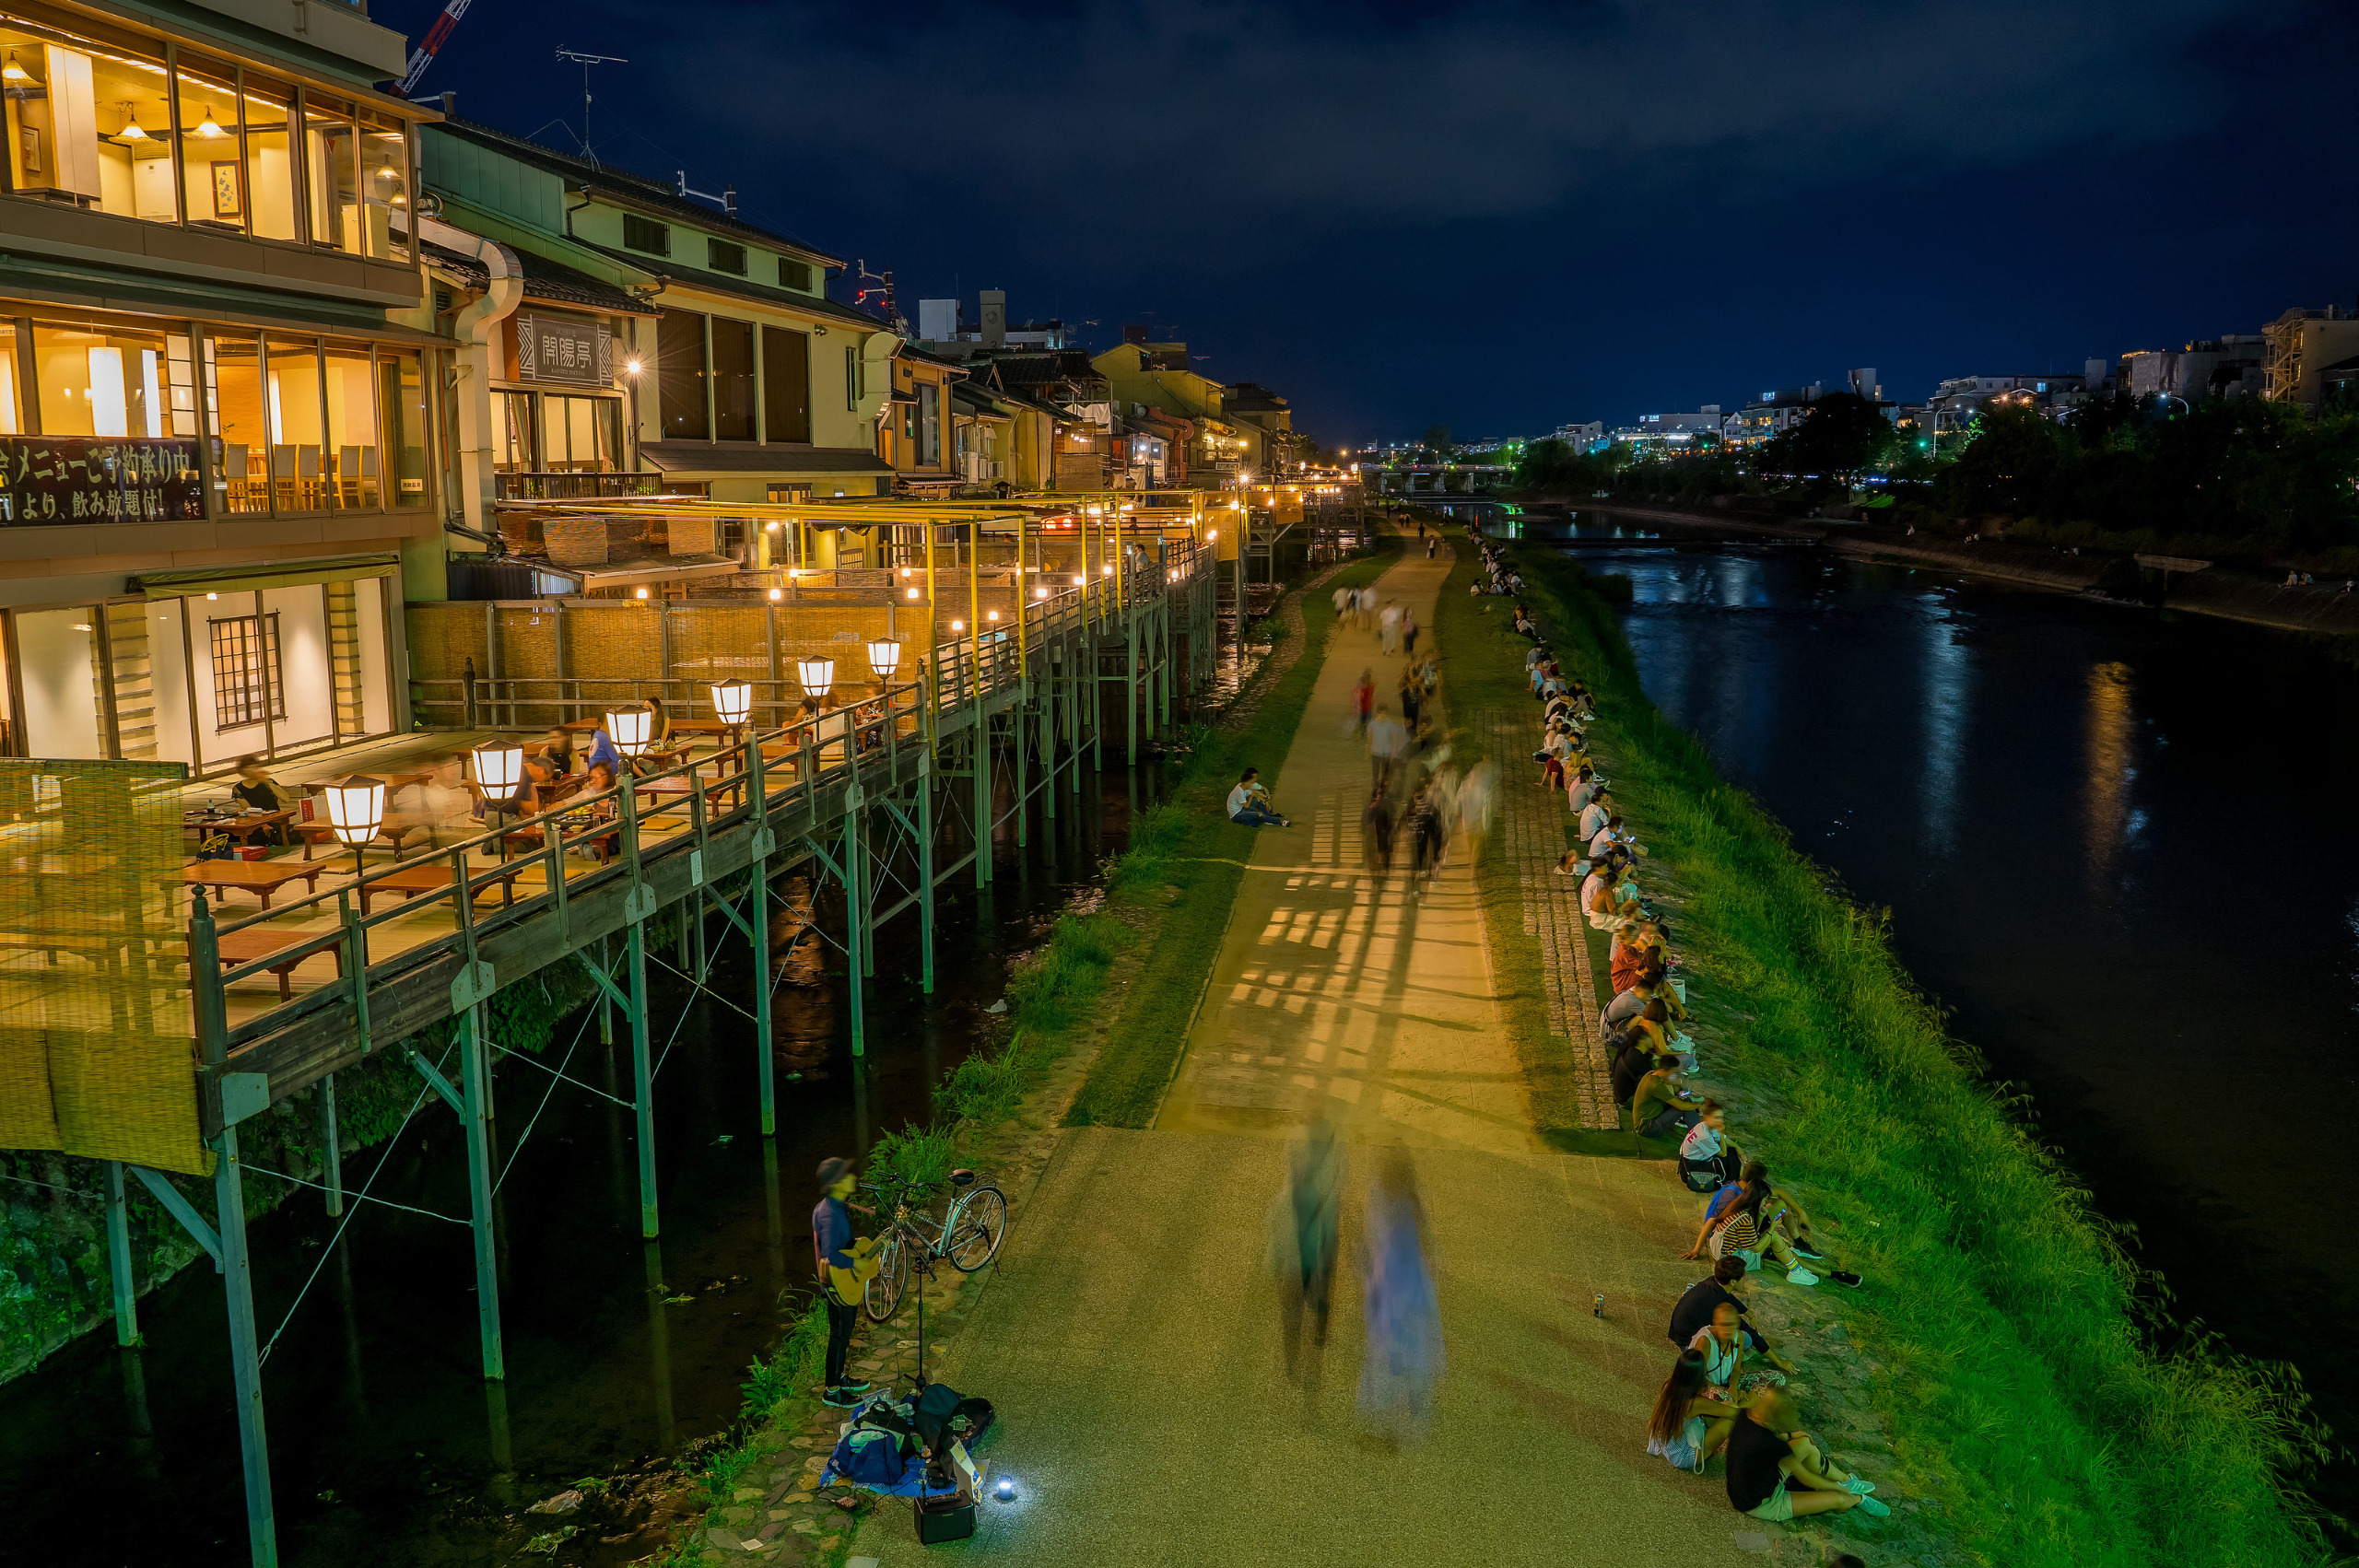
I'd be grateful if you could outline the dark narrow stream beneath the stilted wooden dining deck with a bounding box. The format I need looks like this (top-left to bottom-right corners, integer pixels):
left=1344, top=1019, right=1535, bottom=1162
left=0, top=764, right=1161, bottom=1568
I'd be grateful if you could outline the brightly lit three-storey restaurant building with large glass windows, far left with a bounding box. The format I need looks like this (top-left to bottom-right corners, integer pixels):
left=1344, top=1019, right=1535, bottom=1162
left=0, top=0, right=443, bottom=773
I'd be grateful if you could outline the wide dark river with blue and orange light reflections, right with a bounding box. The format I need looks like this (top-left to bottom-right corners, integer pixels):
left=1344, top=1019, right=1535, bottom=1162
left=1520, top=514, right=2359, bottom=1514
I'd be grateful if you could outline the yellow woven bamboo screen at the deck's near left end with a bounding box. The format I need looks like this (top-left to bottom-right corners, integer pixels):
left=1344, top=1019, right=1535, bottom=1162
left=0, top=759, right=212, bottom=1175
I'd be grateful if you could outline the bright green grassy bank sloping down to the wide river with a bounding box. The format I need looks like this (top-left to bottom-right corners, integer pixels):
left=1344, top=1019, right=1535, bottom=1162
left=1481, top=532, right=2324, bottom=1568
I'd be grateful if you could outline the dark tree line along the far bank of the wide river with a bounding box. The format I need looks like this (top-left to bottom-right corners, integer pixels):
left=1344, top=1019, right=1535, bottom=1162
left=1517, top=393, right=2359, bottom=570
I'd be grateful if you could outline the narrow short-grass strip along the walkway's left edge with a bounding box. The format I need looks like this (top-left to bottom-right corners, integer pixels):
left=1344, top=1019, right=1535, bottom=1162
left=1066, top=543, right=1399, bottom=1127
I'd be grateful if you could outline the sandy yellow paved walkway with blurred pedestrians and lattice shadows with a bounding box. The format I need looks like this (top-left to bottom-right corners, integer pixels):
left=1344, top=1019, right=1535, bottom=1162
left=851, top=544, right=1783, bottom=1568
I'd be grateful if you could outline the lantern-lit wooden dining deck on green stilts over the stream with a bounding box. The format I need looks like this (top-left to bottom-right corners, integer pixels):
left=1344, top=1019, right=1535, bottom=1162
left=12, top=493, right=1366, bottom=1563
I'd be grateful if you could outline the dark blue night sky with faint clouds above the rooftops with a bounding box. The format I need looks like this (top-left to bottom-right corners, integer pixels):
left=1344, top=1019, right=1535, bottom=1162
left=372, top=0, right=2359, bottom=443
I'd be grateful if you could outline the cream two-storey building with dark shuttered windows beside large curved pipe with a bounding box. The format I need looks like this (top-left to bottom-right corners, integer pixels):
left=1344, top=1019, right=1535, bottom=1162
left=413, top=117, right=900, bottom=579
